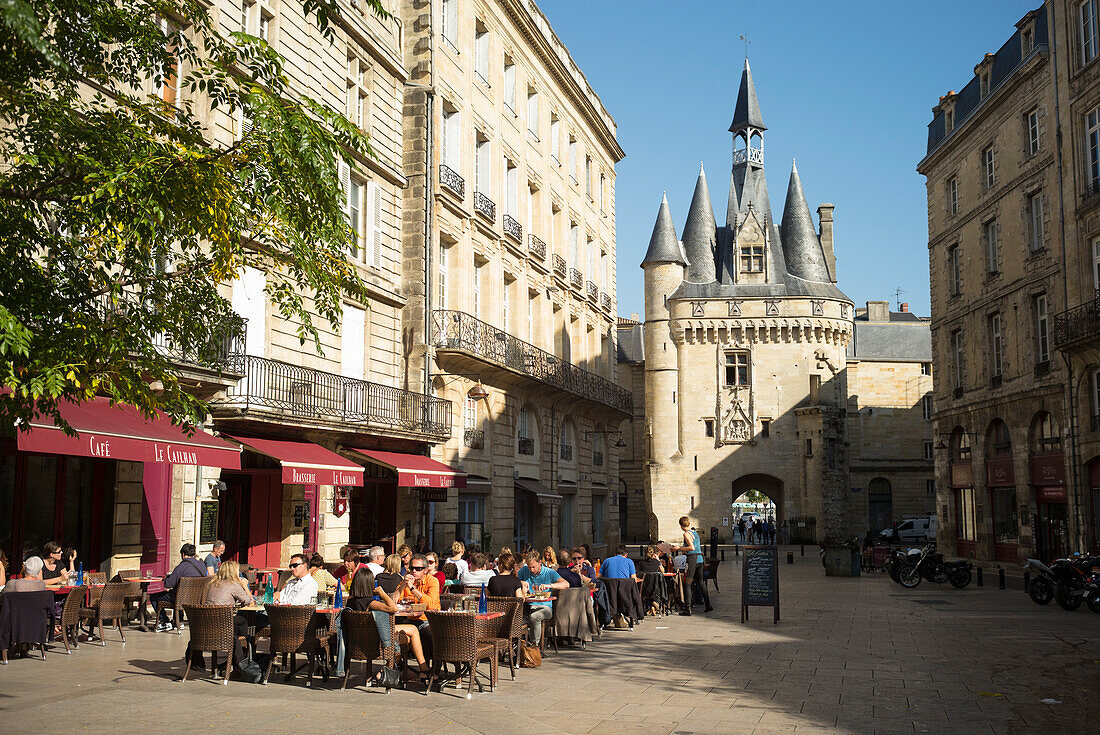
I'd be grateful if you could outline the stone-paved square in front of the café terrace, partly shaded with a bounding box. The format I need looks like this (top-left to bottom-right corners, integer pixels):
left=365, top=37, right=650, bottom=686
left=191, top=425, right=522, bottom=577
left=0, top=547, right=1100, bottom=735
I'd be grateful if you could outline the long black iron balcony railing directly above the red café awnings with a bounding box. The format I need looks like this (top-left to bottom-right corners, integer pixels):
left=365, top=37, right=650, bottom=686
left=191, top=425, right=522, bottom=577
left=211, top=354, right=451, bottom=441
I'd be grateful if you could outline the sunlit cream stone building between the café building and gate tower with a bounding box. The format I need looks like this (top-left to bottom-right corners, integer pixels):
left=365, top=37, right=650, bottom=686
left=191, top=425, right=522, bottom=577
left=402, top=0, right=630, bottom=555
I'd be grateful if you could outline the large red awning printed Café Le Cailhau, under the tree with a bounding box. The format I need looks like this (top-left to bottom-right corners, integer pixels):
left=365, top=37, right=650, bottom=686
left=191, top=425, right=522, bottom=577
left=18, top=398, right=241, bottom=470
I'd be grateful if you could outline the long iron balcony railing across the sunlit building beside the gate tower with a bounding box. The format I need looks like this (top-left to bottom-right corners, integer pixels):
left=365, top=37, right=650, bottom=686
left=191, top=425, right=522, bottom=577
left=431, top=310, right=634, bottom=414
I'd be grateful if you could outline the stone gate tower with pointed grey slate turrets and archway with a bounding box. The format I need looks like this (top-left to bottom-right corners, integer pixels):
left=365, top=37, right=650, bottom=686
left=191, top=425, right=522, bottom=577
left=641, top=61, right=854, bottom=542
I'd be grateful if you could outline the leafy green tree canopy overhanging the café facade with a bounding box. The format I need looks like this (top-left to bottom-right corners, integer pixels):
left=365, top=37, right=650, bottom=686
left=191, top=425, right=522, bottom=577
left=0, top=0, right=387, bottom=427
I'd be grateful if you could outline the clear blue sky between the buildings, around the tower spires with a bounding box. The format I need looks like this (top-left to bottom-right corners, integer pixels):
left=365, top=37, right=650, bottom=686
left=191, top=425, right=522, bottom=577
left=539, top=0, right=1041, bottom=316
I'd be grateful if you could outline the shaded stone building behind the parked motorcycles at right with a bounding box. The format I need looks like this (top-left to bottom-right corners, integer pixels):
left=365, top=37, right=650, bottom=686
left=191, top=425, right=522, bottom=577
left=917, top=0, right=1100, bottom=563
